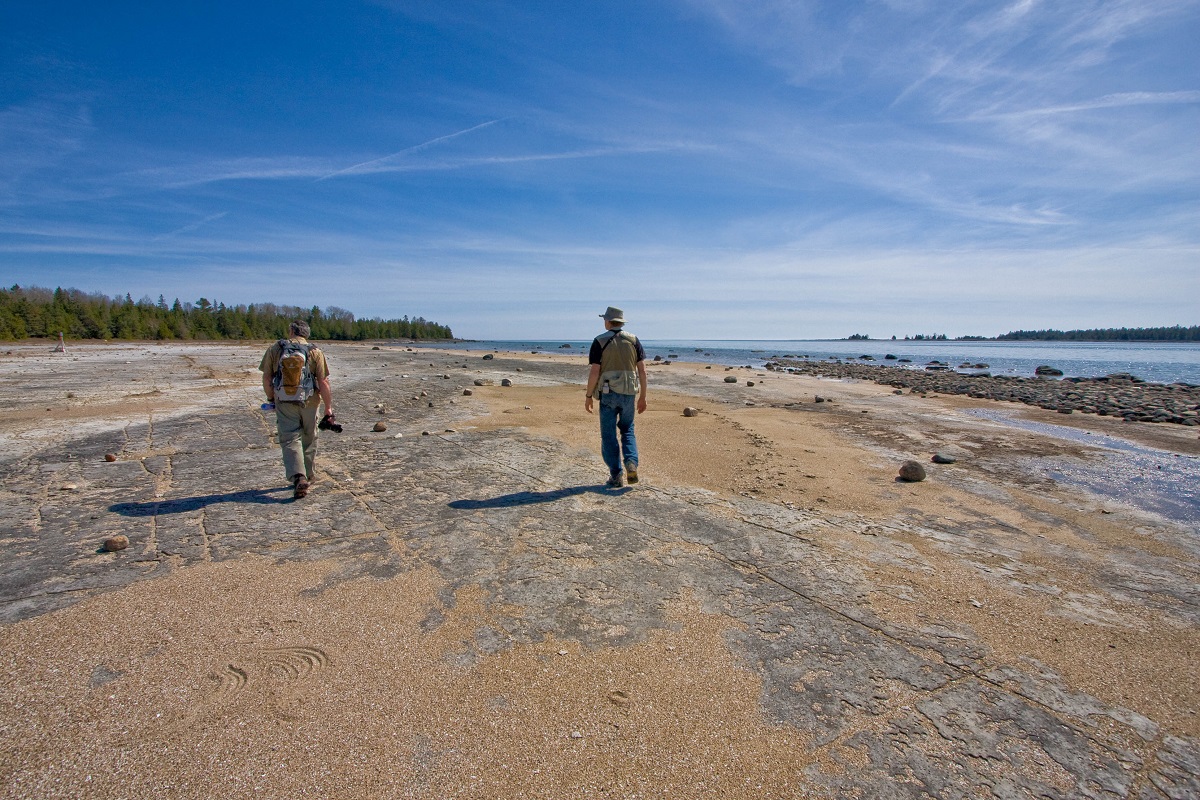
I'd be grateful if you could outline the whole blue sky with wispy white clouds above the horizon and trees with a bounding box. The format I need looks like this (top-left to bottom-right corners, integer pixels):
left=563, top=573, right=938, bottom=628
left=0, top=0, right=1200, bottom=339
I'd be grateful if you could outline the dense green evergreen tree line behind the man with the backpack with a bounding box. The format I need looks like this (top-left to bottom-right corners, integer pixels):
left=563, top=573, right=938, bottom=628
left=0, top=285, right=454, bottom=342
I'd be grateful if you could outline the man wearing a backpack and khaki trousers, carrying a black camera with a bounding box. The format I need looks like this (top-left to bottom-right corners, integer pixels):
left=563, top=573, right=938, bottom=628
left=258, top=320, right=341, bottom=500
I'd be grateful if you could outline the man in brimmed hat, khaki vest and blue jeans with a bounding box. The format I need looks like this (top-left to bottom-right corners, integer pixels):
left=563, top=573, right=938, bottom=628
left=583, top=306, right=646, bottom=489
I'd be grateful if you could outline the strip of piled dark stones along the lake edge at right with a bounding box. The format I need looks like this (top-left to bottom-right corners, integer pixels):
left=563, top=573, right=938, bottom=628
left=766, top=359, right=1200, bottom=426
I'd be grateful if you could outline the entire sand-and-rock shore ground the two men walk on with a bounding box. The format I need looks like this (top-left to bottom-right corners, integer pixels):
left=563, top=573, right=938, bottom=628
left=0, top=343, right=1200, bottom=798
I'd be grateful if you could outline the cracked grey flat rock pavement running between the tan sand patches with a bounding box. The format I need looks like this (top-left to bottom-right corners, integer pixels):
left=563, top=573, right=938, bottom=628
left=0, top=344, right=1200, bottom=798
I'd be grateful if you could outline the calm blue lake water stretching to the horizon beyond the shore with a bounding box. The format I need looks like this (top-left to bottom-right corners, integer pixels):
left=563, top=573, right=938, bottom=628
left=415, top=339, right=1200, bottom=385
